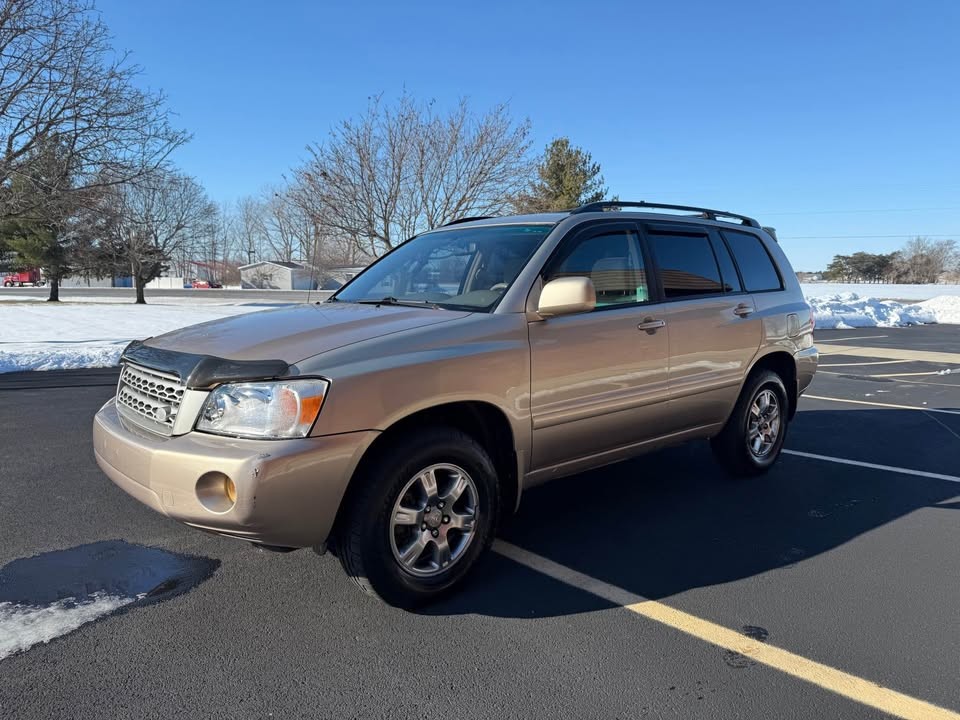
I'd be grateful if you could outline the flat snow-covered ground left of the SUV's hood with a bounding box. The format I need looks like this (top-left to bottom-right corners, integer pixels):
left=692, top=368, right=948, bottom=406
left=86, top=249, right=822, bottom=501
left=0, top=303, right=265, bottom=373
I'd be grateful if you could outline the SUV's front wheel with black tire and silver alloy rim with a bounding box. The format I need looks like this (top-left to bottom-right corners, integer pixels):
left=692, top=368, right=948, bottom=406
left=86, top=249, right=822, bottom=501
left=335, top=428, right=500, bottom=609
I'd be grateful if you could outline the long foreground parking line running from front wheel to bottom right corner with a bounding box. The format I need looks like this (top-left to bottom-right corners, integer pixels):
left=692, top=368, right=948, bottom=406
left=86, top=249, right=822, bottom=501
left=493, top=540, right=960, bottom=720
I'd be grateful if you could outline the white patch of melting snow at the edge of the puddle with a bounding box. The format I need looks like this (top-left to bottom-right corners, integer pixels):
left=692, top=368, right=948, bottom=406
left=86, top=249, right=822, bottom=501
left=0, top=592, right=142, bottom=660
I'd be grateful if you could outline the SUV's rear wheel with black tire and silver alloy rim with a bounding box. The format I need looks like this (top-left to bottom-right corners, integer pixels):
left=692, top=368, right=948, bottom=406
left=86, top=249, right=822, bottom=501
left=710, top=370, right=790, bottom=477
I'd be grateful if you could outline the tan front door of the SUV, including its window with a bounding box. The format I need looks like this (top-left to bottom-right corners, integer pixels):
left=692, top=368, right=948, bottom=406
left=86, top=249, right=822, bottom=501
left=529, top=221, right=669, bottom=473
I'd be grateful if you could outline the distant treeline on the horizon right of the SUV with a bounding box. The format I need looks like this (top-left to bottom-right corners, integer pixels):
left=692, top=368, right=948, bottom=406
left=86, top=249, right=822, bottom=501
left=823, top=237, right=960, bottom=283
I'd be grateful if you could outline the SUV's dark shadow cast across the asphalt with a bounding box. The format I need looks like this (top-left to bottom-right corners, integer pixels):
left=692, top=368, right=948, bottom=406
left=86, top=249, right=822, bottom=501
left=424, top=410, right=960, bottom=617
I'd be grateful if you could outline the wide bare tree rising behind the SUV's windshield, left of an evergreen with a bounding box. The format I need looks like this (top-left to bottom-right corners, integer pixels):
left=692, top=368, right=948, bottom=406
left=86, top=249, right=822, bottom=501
left=291, top=95, right=534, bottom=256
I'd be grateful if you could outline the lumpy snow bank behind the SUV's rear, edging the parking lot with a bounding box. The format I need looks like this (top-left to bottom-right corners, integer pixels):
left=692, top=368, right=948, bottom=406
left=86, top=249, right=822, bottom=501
left=807, top=293, right=960, bottom=329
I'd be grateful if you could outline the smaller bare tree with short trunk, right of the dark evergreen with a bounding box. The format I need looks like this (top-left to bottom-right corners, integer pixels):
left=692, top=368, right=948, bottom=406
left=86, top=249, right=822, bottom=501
left=112, top=172, right=217, bottom=304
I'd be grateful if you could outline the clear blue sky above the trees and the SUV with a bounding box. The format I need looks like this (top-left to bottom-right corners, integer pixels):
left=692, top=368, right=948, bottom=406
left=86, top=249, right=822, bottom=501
left=97, top=0, right=960, bottom=269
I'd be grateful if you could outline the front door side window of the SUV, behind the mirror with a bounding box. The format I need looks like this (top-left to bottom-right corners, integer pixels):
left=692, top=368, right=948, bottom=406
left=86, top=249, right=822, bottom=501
left=544, top=230, right=650, bottom=307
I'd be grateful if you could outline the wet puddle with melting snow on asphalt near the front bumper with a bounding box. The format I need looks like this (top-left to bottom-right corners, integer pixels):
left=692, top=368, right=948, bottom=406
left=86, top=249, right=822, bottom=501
left=0, top=540, right=220, bottom=660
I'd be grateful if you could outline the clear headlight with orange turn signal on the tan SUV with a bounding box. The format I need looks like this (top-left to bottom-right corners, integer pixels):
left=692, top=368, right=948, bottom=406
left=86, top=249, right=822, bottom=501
left=197, top=380, right=330, bottom=438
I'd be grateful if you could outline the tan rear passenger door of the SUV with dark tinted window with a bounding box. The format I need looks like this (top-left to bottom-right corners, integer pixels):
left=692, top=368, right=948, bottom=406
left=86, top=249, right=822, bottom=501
left=644, top=223, right=761, bottom=430
